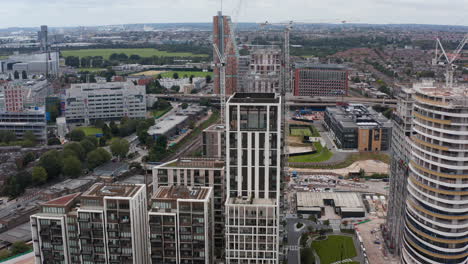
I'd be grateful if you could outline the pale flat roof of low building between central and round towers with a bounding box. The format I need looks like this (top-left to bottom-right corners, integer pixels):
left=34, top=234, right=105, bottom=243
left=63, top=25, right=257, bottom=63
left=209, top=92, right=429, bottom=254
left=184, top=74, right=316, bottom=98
left=296, top=192, right=365, bottom=211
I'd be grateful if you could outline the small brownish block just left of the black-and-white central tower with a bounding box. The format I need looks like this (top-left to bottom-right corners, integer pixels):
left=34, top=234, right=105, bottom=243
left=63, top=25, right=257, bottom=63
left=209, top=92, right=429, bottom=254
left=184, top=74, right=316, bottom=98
left=202, top=124, right=226, bottom=159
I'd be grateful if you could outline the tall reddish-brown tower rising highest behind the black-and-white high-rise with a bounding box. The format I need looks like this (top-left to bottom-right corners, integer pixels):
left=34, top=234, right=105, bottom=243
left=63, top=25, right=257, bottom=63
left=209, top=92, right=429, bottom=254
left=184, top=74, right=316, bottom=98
left=213, top=12, right=239, bottom=96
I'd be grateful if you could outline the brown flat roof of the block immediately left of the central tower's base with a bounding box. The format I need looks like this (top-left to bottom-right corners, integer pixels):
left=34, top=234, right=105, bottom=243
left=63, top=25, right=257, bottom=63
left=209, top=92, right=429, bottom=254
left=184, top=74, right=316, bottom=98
left=152, top=186, right=211, bottom=200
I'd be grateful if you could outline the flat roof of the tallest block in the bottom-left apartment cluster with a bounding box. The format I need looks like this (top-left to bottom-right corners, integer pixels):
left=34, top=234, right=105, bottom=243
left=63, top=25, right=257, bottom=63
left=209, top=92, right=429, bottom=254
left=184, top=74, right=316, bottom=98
left=82, top=183, right=142, bottom=198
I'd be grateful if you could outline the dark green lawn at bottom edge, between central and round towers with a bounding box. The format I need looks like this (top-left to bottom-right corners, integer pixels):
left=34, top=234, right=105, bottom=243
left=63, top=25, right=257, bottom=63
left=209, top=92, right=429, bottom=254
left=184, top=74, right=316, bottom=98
left=312, top=236, right=357, bottom=264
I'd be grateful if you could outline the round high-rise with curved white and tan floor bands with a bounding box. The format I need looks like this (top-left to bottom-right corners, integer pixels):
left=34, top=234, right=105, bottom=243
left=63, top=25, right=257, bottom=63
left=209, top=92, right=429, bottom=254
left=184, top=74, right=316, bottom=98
left=401, top=85, right=468, bottom=264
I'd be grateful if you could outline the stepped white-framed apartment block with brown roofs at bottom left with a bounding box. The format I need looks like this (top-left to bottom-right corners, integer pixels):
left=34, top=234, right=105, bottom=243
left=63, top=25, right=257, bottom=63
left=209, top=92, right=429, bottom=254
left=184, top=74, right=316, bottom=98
left=31, top=183, right=150, bottom=264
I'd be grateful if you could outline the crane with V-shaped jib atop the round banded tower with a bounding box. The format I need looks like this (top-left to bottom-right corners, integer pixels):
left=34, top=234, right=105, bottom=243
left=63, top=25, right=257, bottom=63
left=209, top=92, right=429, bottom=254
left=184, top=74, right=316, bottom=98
left=432, top=34, right=468, bottom=88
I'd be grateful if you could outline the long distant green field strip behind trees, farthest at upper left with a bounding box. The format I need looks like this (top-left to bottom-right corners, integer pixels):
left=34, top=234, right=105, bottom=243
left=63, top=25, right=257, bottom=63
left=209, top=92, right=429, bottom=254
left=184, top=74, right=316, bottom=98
left=61, top=48, right=208, bottom=59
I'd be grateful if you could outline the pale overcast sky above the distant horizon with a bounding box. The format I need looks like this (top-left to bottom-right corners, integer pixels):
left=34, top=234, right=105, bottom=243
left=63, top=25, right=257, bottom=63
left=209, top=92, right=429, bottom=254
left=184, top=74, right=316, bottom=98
left=0, top=0, right=468, bottom=28
